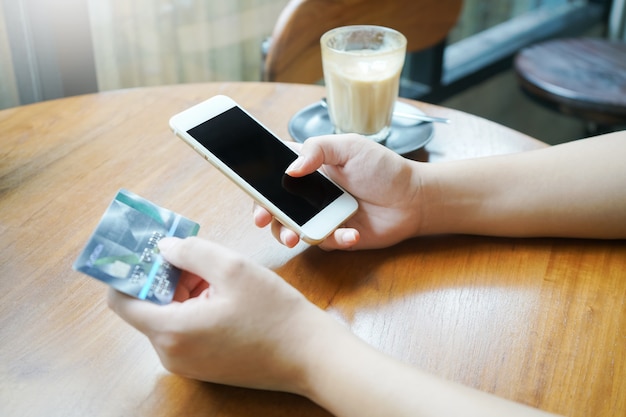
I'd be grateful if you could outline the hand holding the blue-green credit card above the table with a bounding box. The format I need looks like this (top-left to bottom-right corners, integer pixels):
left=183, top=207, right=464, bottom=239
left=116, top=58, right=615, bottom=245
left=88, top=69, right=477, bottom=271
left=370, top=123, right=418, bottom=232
left=108, top=238, right=334, bottom=393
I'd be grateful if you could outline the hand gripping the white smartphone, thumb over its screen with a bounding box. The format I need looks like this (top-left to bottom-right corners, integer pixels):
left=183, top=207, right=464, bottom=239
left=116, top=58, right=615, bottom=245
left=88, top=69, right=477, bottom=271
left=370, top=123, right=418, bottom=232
left=254, top=134, right=421, bottom=250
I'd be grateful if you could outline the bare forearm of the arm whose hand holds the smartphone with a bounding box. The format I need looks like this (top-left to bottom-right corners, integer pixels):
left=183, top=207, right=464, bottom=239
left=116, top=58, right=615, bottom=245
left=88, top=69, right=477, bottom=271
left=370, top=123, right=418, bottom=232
left=420, top=131, right=626, bottom=238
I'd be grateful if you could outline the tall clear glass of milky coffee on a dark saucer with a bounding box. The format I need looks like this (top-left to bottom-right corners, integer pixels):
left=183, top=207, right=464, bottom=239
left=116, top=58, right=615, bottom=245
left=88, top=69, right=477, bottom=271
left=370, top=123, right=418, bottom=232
left=320, top=25, right=406, bottom=142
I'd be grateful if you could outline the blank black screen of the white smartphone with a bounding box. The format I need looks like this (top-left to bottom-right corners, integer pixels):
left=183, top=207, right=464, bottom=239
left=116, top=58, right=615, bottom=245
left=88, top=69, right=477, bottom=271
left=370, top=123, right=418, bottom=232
left=187, top=106, right=342, bottom=226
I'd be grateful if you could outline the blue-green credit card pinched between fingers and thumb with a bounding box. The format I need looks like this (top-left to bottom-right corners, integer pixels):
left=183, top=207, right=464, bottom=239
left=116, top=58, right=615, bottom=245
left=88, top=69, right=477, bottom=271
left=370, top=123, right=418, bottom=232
left=73, top=189, right=200, bottom=304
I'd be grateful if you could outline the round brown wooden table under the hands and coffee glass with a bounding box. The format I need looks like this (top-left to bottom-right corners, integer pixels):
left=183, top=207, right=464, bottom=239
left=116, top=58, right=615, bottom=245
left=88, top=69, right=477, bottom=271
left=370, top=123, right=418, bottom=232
left=0, top=83, right=626, bottom=417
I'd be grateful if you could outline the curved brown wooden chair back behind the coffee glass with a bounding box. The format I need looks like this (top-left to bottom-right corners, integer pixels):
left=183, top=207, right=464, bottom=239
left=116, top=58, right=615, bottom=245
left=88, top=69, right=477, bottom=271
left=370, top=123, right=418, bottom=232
left=262, top=0, right=463, bottom=84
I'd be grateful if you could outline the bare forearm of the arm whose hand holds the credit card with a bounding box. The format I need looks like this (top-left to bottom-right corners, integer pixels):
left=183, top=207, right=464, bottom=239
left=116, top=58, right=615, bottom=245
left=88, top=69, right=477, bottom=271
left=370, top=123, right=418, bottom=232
left=304, top=312, right=552, bottom=417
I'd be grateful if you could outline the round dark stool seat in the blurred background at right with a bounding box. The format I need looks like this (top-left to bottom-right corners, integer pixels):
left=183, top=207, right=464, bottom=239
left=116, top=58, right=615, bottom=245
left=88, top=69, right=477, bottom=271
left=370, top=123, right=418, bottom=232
left=514, top=38, right=626, bottom=133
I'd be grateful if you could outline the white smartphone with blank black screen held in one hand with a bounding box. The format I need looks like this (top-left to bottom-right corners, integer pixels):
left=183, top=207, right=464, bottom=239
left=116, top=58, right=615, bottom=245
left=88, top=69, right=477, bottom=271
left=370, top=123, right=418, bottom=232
left=170, top=95, right=358, bottom=244
